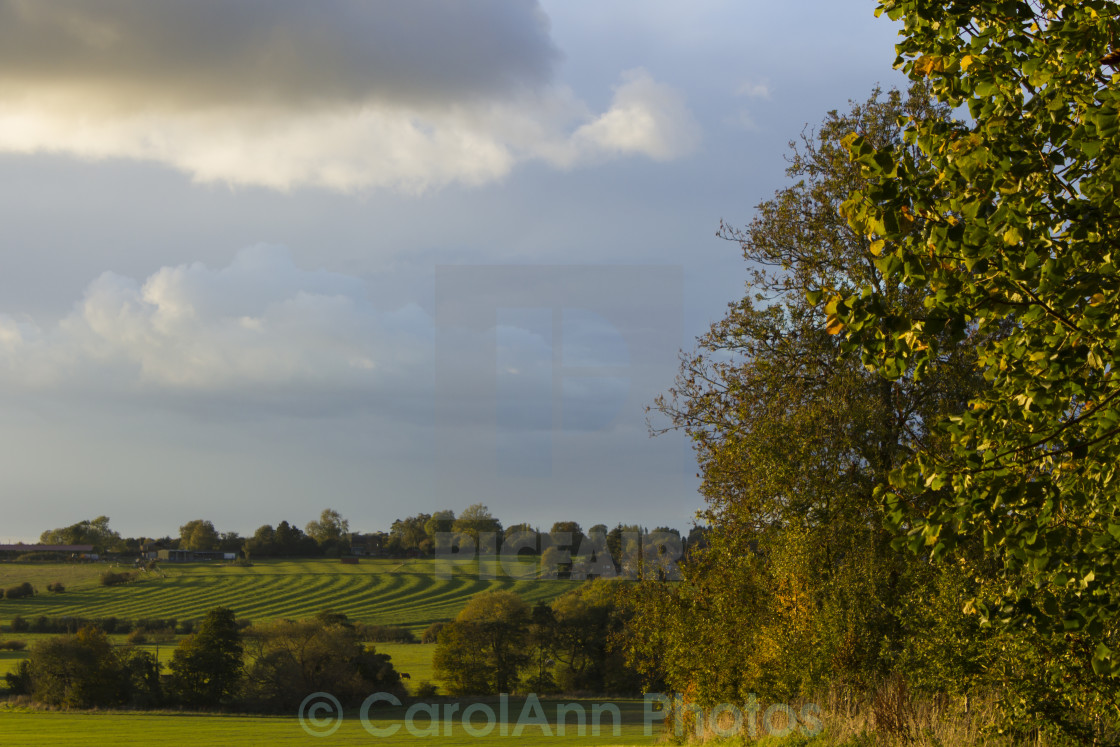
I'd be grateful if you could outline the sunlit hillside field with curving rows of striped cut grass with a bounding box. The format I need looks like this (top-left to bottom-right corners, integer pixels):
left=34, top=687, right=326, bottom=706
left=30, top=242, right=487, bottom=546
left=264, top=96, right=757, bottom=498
left=0, top=559, right=579, bottom=636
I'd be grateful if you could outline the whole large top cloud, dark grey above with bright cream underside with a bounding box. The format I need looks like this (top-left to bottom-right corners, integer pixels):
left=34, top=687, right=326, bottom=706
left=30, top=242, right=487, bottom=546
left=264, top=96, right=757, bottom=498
left=0, top=0, right=699, bottom=193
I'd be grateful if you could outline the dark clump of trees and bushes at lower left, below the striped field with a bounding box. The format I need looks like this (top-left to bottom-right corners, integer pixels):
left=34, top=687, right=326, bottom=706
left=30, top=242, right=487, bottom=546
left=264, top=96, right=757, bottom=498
left=6, top=607, right=404, bottom=712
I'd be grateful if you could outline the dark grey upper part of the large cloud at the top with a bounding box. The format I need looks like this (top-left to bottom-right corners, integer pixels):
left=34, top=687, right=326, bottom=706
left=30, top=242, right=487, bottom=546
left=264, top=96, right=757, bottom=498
left=0, top=0, right=558, bottom=108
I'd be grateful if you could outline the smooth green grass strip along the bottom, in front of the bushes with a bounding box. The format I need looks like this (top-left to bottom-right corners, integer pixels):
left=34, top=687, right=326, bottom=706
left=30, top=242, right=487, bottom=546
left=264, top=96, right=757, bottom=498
left=0, top=698, right=662, bottom=747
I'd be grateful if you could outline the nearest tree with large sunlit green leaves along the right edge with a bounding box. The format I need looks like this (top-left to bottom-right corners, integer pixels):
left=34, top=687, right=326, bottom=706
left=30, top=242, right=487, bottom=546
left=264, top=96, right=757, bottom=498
left=821, top=0, right=1120, bottom=738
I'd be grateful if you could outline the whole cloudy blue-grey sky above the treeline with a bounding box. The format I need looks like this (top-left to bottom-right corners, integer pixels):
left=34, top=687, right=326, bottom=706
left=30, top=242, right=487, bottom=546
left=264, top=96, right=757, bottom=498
left=0, top=0, right=903, bottom=541
